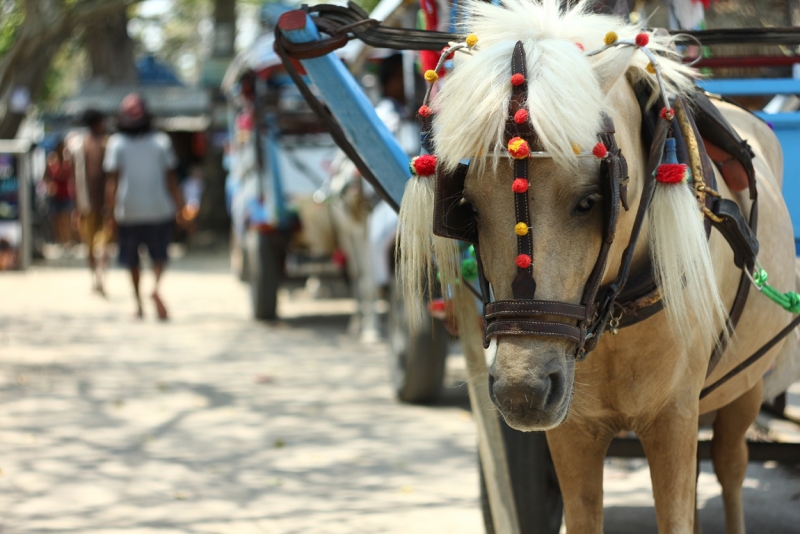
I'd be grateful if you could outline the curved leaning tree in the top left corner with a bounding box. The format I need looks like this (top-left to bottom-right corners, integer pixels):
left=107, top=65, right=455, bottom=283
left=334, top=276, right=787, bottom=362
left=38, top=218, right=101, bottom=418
left=0, top=0, right=137, bottom=139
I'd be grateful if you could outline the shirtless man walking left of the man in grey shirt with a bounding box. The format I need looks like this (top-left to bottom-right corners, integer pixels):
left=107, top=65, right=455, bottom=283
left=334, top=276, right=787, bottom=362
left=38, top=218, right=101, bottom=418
left=69, top=109, right=110, bottom=295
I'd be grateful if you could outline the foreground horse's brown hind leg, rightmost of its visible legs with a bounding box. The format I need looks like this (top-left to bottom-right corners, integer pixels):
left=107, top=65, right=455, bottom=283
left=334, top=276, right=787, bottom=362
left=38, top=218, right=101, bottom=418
left=711, top=380, right=763, bottom=534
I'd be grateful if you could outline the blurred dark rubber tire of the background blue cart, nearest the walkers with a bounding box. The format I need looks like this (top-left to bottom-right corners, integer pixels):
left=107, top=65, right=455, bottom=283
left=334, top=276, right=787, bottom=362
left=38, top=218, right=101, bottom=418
left=245, top=230, right=282, bottom=321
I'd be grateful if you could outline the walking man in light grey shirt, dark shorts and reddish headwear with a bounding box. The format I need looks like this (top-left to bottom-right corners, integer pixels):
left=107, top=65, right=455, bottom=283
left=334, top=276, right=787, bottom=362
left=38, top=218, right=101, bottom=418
left=103, top=94, right=184, bottom=321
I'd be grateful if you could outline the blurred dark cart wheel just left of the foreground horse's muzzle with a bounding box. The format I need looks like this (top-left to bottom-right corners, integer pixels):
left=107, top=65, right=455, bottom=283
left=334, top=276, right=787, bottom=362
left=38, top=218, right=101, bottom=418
left=388, top=281, right=450, bottom=403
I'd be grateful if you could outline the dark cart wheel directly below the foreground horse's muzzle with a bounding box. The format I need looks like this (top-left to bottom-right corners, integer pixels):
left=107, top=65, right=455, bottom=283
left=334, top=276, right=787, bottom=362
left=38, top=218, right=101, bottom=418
left=478, top=428, right=564, bottom=534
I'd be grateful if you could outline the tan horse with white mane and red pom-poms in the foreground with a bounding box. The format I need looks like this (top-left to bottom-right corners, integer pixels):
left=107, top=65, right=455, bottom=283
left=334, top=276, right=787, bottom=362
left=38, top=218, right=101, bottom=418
left=399, top=0, right=800, bottom=534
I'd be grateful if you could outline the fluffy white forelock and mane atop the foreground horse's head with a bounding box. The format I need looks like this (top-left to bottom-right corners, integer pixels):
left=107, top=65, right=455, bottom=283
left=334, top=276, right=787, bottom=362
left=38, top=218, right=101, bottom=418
left=433, top=0, right=693, bottom=170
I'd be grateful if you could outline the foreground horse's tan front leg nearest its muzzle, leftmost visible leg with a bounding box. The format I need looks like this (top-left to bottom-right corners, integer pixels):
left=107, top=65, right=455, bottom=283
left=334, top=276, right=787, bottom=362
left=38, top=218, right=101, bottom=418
left=547, top=421, right=612, bottom=534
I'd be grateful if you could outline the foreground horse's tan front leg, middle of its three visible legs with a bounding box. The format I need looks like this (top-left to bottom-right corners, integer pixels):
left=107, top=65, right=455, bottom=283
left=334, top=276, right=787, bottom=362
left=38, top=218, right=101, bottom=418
left=637, top=399, right=698, bottom=534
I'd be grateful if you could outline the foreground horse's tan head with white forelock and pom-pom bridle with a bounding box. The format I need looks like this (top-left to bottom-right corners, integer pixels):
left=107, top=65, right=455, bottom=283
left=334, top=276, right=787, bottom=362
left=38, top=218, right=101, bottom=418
left=401, top=0, right=724, bottom=430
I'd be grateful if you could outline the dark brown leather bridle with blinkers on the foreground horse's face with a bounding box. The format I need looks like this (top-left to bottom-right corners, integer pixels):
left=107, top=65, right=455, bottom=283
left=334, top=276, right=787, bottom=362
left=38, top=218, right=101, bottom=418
left=433, top=42, right=671, bottom=361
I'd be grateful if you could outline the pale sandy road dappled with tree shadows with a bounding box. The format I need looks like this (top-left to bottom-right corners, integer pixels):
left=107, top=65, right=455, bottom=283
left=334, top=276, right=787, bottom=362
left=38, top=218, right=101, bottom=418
left=0, top=252, right=800, bottom=534
